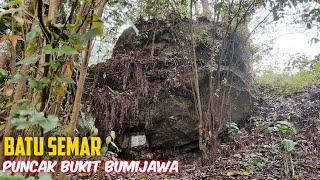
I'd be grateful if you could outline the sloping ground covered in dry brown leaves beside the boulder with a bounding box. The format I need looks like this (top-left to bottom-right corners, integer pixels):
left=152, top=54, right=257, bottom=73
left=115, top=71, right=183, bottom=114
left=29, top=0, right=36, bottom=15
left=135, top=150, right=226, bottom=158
left=72, top=86, right=320, bottom=179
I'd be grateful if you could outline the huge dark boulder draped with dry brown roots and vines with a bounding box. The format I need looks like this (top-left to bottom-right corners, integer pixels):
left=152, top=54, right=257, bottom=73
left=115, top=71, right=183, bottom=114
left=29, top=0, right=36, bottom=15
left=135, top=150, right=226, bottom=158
left=85, top=18, right=253, bottom=156
